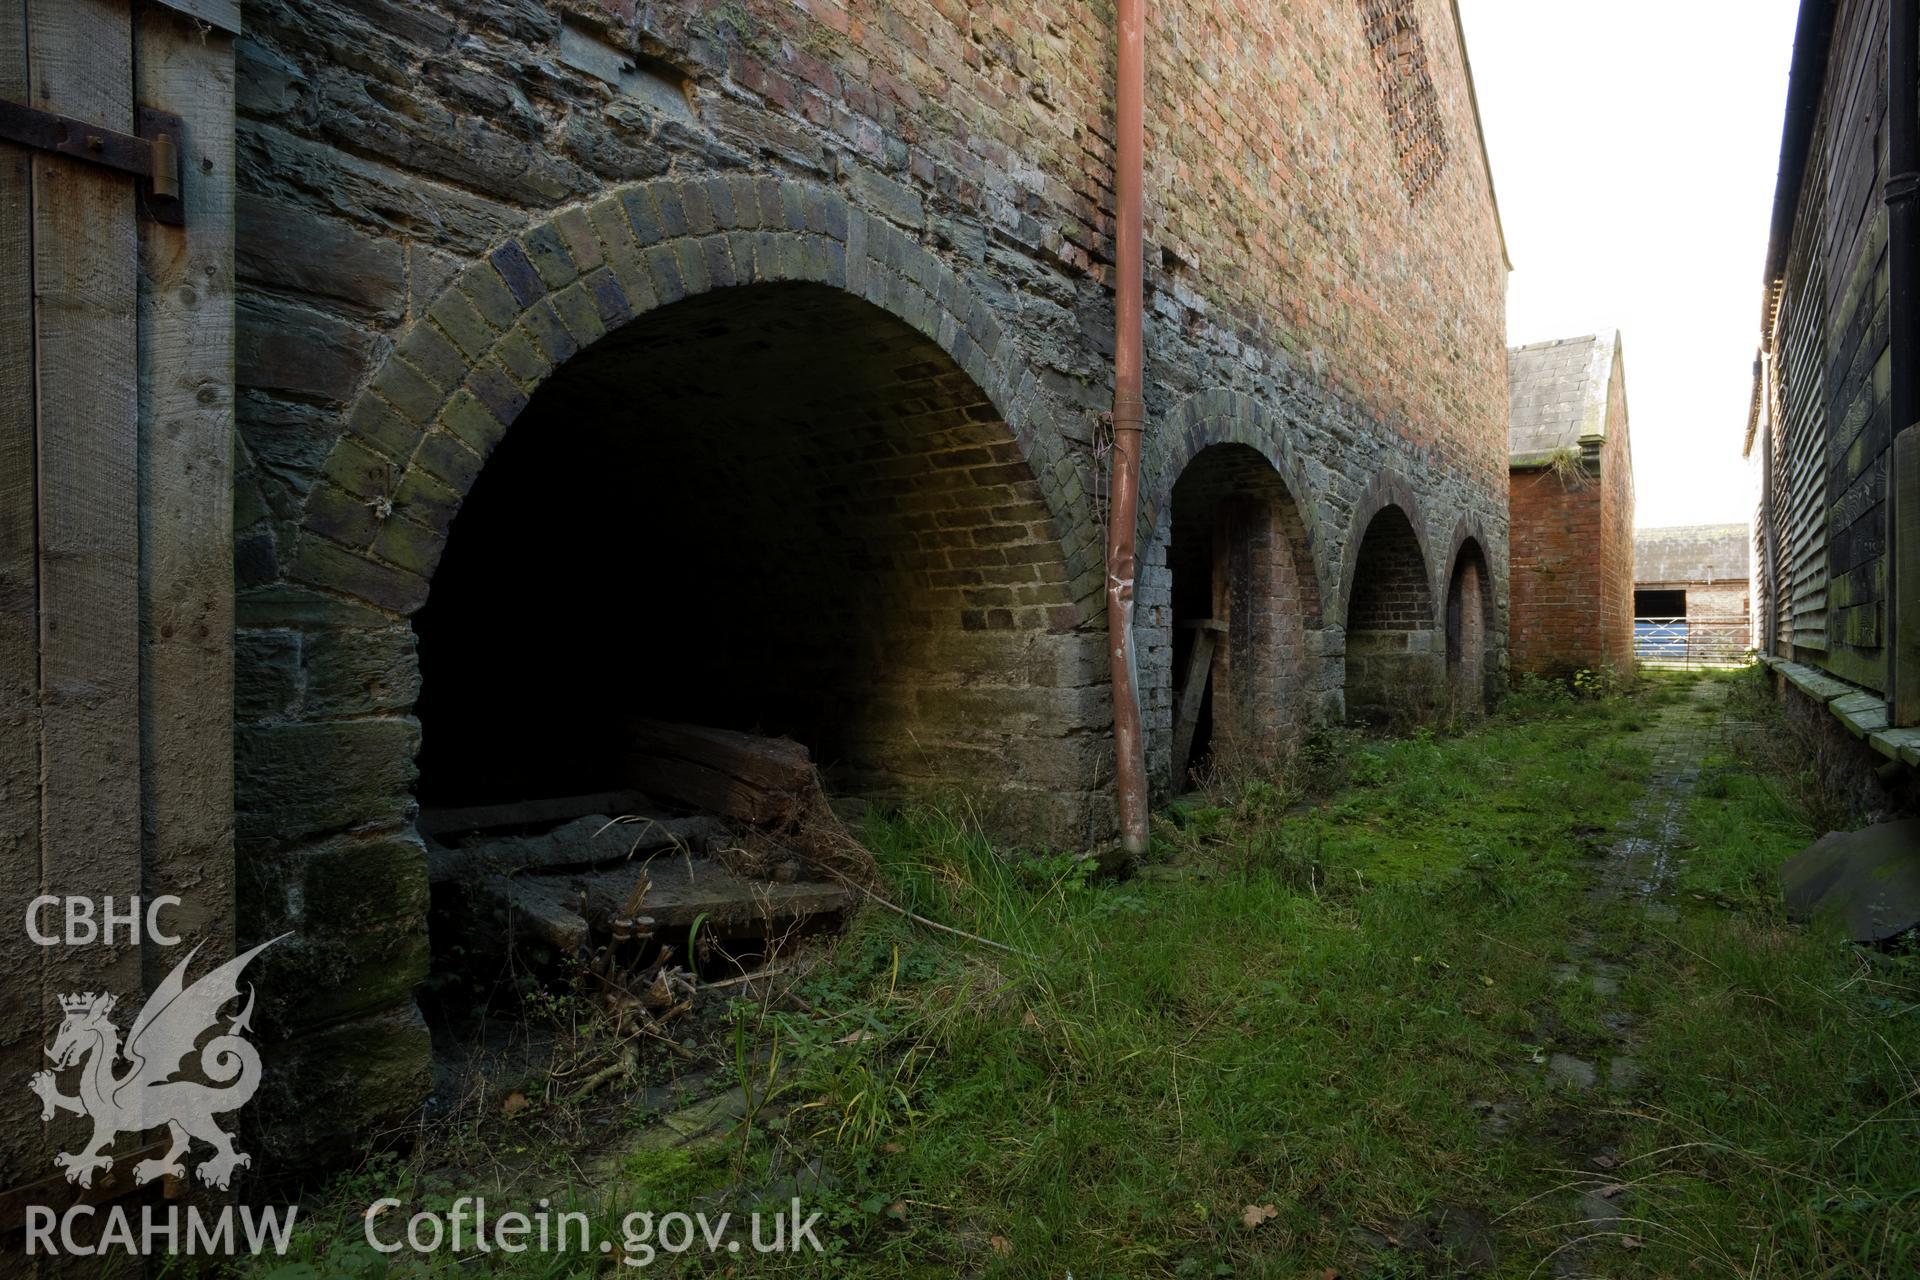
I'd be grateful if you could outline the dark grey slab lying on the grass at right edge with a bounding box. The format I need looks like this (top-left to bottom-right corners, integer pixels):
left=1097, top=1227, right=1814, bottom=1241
left=1780, top=819, right=1920, bottom=942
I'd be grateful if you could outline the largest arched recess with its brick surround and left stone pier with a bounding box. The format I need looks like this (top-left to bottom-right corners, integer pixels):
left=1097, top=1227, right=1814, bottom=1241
left=236, top=175, right=1110, bottom=1125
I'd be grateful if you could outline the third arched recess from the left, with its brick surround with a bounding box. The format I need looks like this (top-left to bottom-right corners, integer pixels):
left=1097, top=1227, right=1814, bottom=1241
left=1346, top=480, right=1446, bottom=725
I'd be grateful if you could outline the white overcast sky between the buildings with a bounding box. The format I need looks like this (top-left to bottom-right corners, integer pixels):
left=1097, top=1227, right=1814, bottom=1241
left=1459, top=0, right=1799, bottom=528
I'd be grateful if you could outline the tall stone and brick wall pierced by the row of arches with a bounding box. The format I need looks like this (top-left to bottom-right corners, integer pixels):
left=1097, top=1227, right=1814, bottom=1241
left=236, top=0, right=1507, bottom=1161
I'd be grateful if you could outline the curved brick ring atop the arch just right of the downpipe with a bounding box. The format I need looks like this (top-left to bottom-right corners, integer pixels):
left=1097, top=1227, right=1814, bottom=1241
left=1140, top=388, right=1332, bottom=629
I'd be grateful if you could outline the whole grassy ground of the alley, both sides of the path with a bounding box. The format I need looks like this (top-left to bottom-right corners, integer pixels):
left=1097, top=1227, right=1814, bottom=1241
left=243, top=676, right=1920, bottom=1280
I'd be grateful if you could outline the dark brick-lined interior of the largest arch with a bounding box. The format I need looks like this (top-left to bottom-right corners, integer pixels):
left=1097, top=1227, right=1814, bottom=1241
left=417, top=284, right=1104, bottom=842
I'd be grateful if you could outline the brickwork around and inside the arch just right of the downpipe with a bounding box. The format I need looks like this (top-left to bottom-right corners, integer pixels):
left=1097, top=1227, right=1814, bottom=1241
left=1135, top=390, right=1340, bottom=791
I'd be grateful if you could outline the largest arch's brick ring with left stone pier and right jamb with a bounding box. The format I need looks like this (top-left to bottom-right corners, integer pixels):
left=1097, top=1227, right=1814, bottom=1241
left=236, top=175, right=1112, bottom=1159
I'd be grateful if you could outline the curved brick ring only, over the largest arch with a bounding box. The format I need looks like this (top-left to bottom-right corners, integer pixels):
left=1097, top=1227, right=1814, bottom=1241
left=288, top=175, right=1100, bottom=616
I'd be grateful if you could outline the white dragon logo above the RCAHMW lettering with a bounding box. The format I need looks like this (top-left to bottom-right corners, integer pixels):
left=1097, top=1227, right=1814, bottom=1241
left=29, top=935, right=286, bottom=1190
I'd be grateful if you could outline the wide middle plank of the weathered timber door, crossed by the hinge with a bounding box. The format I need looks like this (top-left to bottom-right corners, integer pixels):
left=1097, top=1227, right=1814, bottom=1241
left=24, top=0, right=140, bottom=1150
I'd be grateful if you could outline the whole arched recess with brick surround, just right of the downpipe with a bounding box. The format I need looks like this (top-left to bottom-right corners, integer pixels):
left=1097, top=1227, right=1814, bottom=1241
left=1135, top=391, right=1338, bottom=793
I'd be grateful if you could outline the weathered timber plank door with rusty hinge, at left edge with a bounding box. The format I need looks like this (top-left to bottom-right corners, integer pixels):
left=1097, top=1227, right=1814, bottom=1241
left=0, top=0, right=238, bottom=1230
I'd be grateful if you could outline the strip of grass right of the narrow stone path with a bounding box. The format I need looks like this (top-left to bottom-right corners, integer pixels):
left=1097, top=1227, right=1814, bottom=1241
left=1589, top=676, right=1920, bottom=1278
